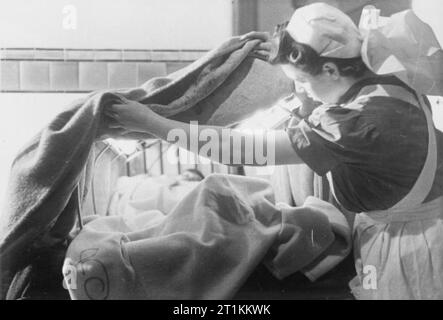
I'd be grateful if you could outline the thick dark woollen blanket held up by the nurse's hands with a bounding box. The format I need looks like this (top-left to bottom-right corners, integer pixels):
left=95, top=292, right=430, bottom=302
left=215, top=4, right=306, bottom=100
left=0, top=38, right=292, bottom=297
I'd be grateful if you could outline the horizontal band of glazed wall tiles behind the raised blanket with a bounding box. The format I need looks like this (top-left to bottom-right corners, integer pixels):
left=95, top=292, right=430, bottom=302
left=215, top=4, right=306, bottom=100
left=0, top=49, right=205, bottom=93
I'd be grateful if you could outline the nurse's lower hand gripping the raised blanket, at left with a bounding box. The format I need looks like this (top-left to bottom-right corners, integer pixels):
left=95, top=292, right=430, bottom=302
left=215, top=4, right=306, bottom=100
left=105, top=99, right=156, bottom=132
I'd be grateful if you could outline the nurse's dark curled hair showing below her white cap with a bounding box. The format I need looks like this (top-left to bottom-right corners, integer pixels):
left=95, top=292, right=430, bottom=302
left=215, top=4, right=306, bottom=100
left=269, top=26, right=368, bottom=78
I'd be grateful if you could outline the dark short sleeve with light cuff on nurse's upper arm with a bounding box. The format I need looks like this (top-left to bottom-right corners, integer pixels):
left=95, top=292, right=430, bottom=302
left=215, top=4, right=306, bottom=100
left=286, top=105, right=377, bottom=176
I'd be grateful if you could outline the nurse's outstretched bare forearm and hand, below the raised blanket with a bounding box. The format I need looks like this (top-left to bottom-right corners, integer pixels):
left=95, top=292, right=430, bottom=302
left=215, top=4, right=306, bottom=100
left=111, top=105, right=302, bottom=166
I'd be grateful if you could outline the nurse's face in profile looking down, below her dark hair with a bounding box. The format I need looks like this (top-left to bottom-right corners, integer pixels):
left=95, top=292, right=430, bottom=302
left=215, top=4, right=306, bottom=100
left=281, top=63, right=343, bottom=103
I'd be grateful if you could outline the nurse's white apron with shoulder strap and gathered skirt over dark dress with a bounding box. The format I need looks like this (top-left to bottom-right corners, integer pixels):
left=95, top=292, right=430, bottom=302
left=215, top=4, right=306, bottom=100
left=328, top=85, right=443, bottom=299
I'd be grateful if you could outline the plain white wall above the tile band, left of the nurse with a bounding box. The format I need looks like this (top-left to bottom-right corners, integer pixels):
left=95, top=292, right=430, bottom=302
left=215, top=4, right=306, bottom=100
left=0, top=0, right=232, bottom=49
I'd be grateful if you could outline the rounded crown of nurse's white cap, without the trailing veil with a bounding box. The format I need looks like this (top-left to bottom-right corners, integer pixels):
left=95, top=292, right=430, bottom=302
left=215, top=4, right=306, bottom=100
left=286, top=3, right=362, bottom=59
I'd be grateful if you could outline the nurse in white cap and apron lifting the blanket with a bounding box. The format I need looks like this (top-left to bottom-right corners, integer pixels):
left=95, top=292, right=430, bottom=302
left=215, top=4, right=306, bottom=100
left=108, top=3, right=443, bottom=299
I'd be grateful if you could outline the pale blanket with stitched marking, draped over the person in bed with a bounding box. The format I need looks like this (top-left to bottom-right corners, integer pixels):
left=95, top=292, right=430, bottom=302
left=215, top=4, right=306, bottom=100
left=63, top=174, right=350, bottom=299
